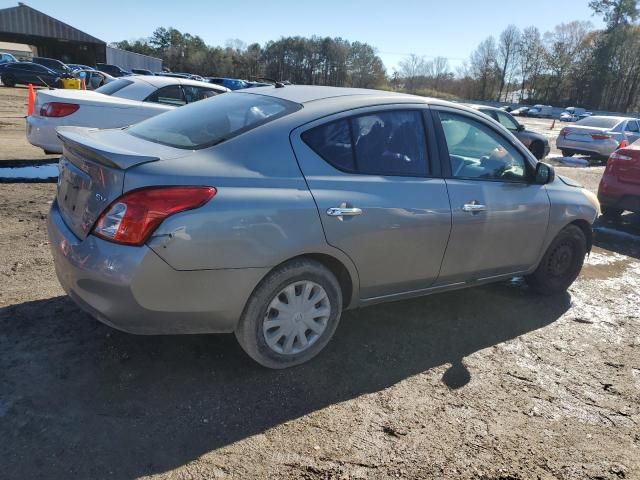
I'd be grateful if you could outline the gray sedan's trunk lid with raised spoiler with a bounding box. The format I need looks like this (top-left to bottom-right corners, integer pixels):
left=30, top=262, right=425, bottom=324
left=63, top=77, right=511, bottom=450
left=56, top=127, right=185, bottom=240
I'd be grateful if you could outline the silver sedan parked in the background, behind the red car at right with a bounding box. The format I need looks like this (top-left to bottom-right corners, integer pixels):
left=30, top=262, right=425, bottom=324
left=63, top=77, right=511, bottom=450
left=556, top=115, right=640, bottom=158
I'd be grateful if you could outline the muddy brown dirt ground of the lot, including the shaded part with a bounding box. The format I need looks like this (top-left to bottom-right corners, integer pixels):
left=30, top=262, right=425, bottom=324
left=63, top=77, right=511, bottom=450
left=0, top=84, right=640, bottom=480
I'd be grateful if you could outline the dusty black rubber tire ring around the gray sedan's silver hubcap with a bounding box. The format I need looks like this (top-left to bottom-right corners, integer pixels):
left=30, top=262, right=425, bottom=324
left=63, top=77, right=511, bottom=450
left=236, top=261, right=342, bottom=368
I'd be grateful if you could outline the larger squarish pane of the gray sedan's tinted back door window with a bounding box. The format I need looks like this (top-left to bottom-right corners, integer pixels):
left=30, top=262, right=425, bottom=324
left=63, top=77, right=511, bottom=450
left=351, top=110, right=428, bottom=176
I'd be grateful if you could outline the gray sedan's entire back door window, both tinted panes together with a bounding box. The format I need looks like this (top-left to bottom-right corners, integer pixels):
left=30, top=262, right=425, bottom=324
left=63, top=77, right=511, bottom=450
left=302, top=110, right=430, bottom=176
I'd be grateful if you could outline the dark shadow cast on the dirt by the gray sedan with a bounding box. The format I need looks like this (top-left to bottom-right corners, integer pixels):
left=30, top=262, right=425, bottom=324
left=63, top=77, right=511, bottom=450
left=0, top=283, right=570, bottom=479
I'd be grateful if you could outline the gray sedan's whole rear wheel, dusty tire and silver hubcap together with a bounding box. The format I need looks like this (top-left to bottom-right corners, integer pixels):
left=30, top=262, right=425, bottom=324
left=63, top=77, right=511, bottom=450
left=235, top=259, right=342, bottom=369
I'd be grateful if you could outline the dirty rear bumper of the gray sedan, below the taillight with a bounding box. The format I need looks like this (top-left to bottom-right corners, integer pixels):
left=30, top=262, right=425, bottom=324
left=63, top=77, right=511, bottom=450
left=47, top=202, right=267, bottom=334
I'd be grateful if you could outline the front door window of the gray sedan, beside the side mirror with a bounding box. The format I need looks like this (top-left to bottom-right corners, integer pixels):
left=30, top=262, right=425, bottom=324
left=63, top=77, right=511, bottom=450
left=439, top=112, right=527, bottom=181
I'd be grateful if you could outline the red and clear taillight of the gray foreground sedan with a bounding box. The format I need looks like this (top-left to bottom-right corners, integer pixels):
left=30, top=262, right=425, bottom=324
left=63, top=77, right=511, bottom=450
left=93, top=187, right=216, bottom=245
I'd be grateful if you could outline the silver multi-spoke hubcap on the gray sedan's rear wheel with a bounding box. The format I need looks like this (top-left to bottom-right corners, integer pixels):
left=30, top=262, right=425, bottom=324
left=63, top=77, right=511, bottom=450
left=262, top=280, right=331, bottom=355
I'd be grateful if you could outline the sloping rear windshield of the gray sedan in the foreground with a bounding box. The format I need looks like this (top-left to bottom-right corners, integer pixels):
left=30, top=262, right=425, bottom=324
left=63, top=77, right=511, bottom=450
left=128, top=93, right=302, bottom=149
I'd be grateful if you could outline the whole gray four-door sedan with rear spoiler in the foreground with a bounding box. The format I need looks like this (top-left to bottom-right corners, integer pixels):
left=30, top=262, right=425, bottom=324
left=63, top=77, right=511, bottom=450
left=48, top=85, right=599, bottom=368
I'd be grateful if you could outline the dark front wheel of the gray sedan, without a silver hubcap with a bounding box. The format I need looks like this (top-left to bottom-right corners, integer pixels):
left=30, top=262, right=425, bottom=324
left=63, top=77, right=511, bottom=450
left=525, top=225, right=587, bottom=295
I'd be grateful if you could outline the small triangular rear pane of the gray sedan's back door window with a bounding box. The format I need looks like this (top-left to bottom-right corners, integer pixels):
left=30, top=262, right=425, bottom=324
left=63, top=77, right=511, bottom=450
left=302, top=120, right=356, bottom=172
